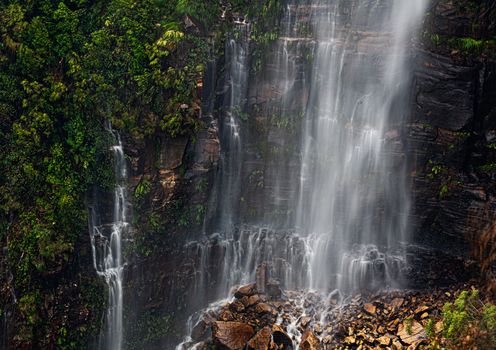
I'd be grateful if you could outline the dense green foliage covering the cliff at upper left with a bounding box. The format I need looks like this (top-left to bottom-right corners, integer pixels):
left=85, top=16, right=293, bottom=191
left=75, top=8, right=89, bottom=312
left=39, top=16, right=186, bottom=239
left=0, top=0, right=279, bottom=349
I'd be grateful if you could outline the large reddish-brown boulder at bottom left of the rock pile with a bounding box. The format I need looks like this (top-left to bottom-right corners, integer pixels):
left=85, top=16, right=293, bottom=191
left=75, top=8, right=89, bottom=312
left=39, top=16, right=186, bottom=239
left=212, top=321, right=255, bottom=350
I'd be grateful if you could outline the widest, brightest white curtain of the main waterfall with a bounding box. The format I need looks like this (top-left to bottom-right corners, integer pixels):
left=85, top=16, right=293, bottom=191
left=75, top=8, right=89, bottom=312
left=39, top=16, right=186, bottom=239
left=288, top=0, right=425, bottom=291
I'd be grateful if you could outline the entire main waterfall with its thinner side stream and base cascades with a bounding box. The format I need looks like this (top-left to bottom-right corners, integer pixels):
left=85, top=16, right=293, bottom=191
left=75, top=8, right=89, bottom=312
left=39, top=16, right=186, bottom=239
left=177, top=0, right=427, bottom=349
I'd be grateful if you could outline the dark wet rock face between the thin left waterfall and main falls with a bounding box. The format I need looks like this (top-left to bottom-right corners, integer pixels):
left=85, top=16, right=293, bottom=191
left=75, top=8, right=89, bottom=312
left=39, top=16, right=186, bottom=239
left=119, top=116, right=220, bottom=348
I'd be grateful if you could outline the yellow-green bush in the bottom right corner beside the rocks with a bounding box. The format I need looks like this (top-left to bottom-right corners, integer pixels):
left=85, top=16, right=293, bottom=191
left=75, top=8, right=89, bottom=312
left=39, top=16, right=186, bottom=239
left=426, top=290, right=496, bottom=350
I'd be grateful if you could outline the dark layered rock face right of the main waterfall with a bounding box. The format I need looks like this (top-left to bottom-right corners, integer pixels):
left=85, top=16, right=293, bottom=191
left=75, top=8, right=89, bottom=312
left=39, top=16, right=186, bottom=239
left=404, top=0, right=496, bottom=252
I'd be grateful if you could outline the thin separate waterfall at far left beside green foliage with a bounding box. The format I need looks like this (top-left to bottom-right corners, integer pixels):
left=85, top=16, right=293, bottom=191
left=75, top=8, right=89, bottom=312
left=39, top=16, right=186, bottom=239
left=89, top=126, right=129, bottom=350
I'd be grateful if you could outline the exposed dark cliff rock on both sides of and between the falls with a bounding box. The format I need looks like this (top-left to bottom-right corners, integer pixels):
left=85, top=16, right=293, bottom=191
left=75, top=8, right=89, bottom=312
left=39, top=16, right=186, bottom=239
left=117, top=0, right=496, bottom=348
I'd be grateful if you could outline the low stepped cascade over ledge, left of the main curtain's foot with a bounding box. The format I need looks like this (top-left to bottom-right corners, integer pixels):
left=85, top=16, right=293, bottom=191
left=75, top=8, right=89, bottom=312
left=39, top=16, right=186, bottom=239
left=188, top=228, right=309, bottom=300
